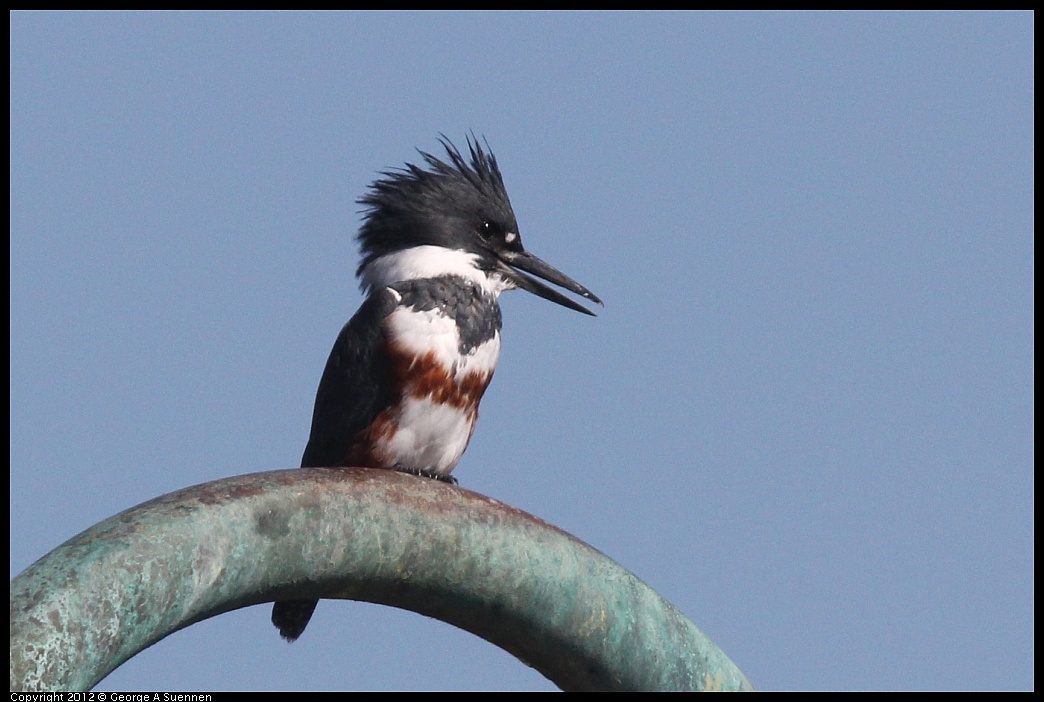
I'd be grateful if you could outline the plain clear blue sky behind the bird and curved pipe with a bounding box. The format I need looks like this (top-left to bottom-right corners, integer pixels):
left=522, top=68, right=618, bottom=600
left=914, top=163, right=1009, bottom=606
left=10, top=13, right=1034, bottom=691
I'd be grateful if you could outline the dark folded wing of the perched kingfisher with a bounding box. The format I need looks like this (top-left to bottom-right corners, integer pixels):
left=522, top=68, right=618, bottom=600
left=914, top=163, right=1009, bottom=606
left=301, top=289, right=396, bottom=468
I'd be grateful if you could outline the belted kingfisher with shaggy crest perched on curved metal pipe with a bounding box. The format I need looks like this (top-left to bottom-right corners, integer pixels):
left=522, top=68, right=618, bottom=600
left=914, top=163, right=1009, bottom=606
left=271, top=137, right=602, bottom=641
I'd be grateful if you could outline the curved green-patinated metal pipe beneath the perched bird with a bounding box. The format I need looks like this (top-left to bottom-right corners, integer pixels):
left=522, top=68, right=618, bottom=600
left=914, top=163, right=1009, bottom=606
left=10, top=468, right=751, bottom=691
